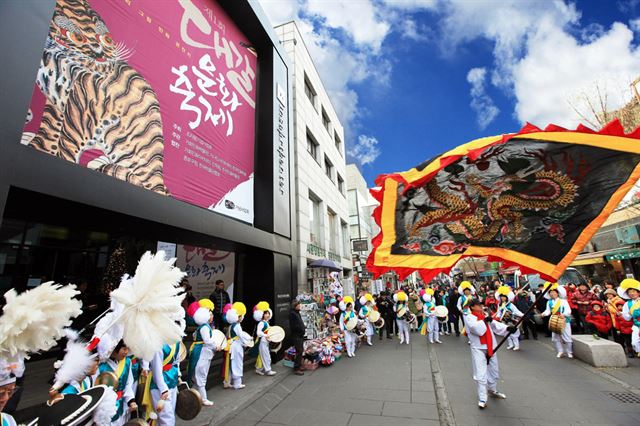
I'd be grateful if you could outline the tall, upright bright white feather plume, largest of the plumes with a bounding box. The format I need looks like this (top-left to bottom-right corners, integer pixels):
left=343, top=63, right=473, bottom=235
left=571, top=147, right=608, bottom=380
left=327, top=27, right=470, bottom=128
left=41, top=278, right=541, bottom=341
left=111, top=251, right=185, bottom=359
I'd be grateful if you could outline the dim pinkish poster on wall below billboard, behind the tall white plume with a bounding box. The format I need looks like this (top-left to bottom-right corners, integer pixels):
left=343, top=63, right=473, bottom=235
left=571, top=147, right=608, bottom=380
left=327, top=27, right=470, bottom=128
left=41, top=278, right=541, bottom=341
left=176, top=244, right=235, bottom=299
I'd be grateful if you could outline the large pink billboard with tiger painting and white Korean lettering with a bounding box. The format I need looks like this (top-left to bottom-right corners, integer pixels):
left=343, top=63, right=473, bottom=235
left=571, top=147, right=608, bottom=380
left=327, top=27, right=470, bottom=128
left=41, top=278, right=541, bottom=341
left=21, top=0, right=257, bottom=223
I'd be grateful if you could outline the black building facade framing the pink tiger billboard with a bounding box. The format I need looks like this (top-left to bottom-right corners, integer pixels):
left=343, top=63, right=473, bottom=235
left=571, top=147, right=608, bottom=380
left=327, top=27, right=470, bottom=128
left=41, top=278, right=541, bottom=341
left=0, top=0, right=297, bottom=328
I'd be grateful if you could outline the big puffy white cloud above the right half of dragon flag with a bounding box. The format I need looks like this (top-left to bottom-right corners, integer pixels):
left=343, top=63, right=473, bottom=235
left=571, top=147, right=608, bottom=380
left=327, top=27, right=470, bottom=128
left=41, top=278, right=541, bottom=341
left=513, top=23, right=640, bottom=127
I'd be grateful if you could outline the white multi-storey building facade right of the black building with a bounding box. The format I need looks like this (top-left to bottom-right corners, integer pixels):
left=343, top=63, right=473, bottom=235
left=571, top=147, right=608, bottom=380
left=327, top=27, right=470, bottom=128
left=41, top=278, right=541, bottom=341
left=275, top=22, right=352, bottom=292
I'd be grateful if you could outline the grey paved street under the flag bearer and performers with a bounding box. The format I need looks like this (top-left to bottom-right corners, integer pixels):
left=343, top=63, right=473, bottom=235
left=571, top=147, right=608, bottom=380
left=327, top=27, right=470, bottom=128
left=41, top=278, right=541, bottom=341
left=184, top=333, right=640, bottom=426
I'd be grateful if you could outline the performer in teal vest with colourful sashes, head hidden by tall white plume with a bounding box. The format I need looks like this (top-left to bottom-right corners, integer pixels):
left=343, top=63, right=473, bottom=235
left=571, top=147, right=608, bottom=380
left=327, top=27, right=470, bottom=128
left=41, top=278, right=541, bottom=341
left=149, top=342, right=180, bottom=426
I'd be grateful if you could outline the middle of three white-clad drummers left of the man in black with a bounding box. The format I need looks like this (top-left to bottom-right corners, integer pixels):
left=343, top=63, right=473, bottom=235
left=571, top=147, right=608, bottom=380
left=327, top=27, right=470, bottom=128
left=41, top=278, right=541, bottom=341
left=223, top=302, right=251, bottom=389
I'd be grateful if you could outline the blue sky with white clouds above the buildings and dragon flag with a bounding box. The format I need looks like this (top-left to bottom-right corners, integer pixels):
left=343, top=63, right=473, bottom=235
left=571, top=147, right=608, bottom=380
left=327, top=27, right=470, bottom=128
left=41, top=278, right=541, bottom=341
left=260, top=0, right=640, bottom=185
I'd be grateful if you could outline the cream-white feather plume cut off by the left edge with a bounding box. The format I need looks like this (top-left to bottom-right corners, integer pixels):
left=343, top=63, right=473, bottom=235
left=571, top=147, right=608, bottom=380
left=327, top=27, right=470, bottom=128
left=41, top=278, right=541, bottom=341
left=0, top=281, right=82, bottom=356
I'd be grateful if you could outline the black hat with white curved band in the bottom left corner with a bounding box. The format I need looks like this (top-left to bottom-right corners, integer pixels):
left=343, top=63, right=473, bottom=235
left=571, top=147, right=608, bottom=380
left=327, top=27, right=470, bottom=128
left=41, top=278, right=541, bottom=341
left=29, top=385, right=107, bottom=426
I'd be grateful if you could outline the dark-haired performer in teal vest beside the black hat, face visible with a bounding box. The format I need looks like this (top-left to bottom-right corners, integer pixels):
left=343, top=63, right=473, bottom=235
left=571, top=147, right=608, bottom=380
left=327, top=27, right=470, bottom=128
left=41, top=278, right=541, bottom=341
left=98, top=336, right=138, bottom=426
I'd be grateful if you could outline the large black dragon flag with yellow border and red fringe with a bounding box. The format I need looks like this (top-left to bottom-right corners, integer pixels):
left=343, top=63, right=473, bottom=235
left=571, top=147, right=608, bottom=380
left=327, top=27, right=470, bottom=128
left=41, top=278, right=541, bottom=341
left=367, top=121, right=640, bottom=281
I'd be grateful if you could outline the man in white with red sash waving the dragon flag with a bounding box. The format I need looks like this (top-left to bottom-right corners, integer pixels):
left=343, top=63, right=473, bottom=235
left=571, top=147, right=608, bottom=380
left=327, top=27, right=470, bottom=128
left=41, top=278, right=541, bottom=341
left=464, top=299, right=515, bottom=409
